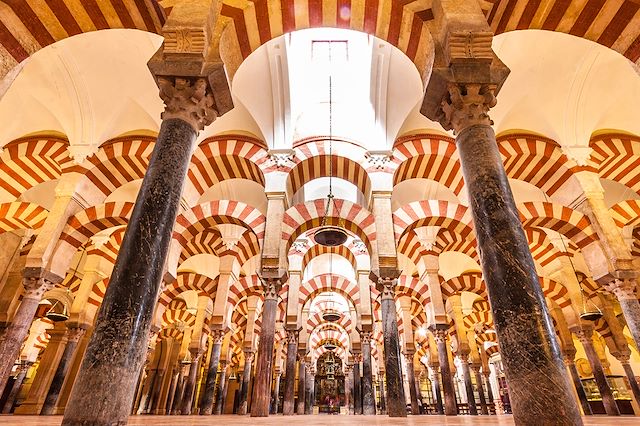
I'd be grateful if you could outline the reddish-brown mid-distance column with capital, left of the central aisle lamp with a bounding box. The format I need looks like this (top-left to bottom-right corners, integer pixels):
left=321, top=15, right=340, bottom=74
left=251, top=278, right=281, bottom=417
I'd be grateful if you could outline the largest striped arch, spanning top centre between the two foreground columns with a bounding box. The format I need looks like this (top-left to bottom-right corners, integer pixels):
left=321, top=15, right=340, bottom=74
left=221, top=0, right=433, bottom=73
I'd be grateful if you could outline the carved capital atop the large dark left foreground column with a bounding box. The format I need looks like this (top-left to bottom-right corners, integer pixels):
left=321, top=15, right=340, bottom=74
left=158, top=77, right=218, bottom=132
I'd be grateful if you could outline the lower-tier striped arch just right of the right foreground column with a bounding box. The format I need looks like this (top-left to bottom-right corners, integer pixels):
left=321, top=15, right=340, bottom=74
left=518, top=201, right=597, bottom=248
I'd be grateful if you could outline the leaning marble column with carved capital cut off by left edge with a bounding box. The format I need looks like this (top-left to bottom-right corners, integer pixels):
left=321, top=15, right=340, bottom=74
left=0, top=269, right=54, bottom=394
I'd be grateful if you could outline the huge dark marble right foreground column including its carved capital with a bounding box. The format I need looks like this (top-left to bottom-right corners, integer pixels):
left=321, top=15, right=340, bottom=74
left=450, top=89, right=582, bottom=426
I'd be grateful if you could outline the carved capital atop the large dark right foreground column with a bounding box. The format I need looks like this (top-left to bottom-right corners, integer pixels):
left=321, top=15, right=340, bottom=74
left=440, top=83, right=497, bottom=133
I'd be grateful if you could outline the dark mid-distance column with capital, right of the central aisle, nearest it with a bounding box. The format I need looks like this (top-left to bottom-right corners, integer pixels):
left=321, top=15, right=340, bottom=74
left=379, top=278, right=407, bottom=417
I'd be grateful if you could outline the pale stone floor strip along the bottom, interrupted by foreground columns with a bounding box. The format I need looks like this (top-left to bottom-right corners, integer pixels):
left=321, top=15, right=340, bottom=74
left=0, top=415, right=640, bottom=426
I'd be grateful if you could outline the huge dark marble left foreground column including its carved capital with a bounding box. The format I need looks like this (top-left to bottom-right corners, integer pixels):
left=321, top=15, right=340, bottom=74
left=63, top=77, right=217, bottom=426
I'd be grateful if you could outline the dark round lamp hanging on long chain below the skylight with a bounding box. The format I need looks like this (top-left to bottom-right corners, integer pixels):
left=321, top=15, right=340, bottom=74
left=313, top=42, right=349, bottom=247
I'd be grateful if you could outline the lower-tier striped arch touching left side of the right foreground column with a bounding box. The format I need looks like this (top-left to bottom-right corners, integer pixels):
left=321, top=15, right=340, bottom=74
left=393, top=200, right=472, bottom=240
